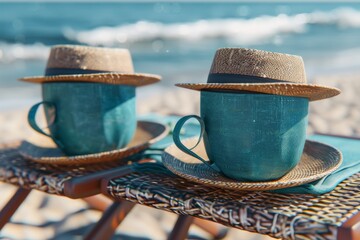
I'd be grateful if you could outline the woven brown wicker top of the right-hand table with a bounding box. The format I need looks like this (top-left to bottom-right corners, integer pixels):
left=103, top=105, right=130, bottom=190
left=108, top=170, right=360, bottom=239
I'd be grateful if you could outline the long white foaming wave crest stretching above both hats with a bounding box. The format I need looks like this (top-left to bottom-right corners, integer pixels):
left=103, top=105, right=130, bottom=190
left=65, top=15, right=304, bottom=46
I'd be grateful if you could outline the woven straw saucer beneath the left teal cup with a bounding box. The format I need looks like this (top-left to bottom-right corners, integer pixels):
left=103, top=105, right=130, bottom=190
left=19, top=121, right=169, bottom=165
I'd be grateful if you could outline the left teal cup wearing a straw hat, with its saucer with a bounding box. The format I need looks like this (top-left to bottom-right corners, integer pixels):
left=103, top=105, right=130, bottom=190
left=20, top=45, right=170, bottom=163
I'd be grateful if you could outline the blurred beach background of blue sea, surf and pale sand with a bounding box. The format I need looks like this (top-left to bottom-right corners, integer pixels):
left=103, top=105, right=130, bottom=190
left=0, top=1, right=360, bottom=239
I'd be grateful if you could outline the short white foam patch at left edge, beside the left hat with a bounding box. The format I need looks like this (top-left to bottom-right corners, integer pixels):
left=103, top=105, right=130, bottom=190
left=0, top=42, right=49, bottom=63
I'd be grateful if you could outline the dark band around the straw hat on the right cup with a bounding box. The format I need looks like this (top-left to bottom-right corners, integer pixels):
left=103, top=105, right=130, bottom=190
left=207, top=73, right=293, bottom=83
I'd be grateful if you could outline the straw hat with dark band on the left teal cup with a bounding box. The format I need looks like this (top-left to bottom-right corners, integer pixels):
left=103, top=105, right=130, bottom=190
left=20, top=45, right=161, bottom=86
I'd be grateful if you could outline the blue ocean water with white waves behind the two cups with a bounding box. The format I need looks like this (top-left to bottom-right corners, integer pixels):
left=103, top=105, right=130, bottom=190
left=0, top=2, right=360, bottom=109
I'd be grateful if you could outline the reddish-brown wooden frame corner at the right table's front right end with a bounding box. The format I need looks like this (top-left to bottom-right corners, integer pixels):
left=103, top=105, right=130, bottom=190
left=337, top=213, right=360, bottom=240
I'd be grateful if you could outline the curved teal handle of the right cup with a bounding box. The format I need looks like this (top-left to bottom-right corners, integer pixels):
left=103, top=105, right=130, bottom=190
left=173, top=115, right=221, bottom=172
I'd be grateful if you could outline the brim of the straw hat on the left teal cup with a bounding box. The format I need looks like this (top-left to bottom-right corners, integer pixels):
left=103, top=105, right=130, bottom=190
left=19, top=73, right=161, bottom=87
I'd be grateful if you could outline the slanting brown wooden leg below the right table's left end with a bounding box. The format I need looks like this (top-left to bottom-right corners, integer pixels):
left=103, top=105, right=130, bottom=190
left=84, top=201, right=136, bottom=240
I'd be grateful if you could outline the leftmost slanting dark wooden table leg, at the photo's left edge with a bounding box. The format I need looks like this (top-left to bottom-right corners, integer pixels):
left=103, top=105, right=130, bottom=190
left=0, top=188, right=31, bottom=230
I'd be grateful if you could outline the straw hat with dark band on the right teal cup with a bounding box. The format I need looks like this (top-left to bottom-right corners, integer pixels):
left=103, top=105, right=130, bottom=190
left=176, top=48, right=340, bottom=101
